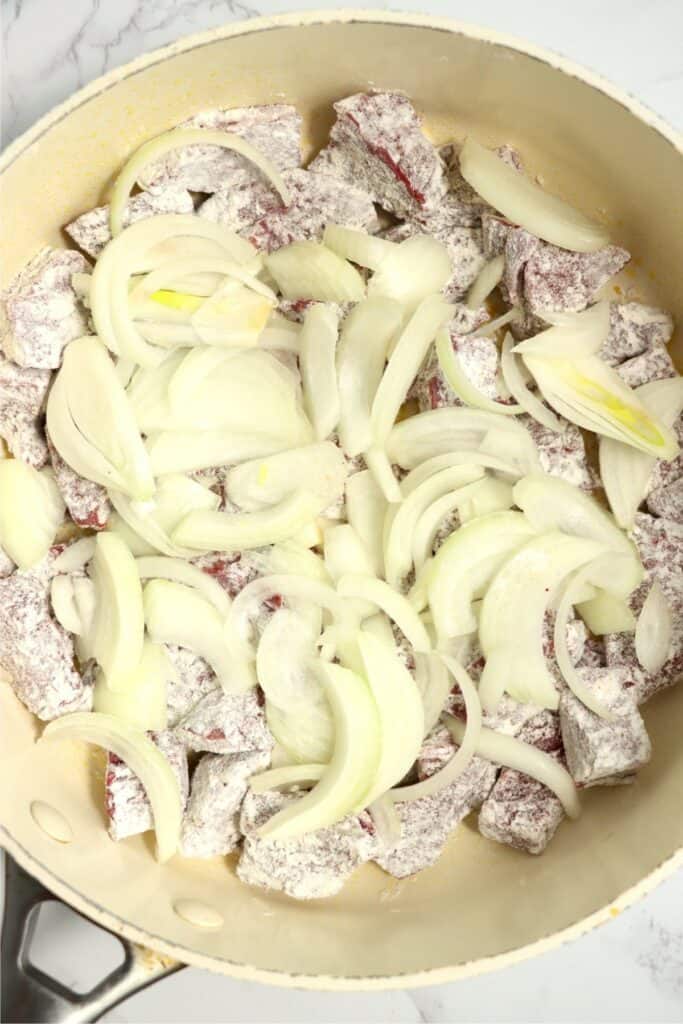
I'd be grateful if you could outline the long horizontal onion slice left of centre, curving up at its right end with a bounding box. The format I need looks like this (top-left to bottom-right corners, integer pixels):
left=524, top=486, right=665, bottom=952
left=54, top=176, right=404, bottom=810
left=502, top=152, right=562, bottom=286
left=171, top=490, right=323, bottom=551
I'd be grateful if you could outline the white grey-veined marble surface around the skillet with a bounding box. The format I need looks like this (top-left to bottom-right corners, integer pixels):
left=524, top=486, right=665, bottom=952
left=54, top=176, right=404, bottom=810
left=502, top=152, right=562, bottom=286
left=1, top=0, right=683, bottom=1024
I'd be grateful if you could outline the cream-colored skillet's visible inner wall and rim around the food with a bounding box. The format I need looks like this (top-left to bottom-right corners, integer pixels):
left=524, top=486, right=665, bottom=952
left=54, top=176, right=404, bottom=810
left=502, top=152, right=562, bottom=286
left=0, top=11, right=683, bottom=1020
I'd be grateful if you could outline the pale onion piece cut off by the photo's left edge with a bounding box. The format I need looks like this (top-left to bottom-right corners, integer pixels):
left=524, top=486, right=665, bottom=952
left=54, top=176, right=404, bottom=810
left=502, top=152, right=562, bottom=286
left=0, top=459, right=65, bottom=569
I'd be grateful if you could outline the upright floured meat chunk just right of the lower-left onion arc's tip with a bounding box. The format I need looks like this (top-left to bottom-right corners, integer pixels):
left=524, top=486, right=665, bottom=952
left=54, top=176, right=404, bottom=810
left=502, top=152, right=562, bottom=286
left=180, top=751, right=270, bottom=857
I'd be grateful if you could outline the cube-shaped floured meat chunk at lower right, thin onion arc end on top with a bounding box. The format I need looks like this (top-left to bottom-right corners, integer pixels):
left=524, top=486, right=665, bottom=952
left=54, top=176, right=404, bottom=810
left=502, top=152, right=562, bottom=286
left=559, top=668, right=651, bottom=786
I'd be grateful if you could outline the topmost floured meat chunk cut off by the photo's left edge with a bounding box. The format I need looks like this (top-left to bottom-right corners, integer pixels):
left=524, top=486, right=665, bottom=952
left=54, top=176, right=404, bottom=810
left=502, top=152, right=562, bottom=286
left=0, top=249, right=90, bottom=370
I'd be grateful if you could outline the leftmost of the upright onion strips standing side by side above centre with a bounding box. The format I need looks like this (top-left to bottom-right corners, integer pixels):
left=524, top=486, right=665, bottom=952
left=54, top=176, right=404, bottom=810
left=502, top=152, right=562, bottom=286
left=299, top=304, right=340, bottom=440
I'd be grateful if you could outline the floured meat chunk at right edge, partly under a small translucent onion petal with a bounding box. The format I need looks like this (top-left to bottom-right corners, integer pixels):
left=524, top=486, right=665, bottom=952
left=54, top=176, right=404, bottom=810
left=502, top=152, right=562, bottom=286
left=605, top=512, right=683, bottom=703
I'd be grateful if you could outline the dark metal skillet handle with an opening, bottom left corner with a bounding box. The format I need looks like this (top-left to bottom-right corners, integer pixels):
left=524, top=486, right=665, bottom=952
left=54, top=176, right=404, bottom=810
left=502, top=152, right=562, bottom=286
left=0, top=853, right=184, bottom=1024
